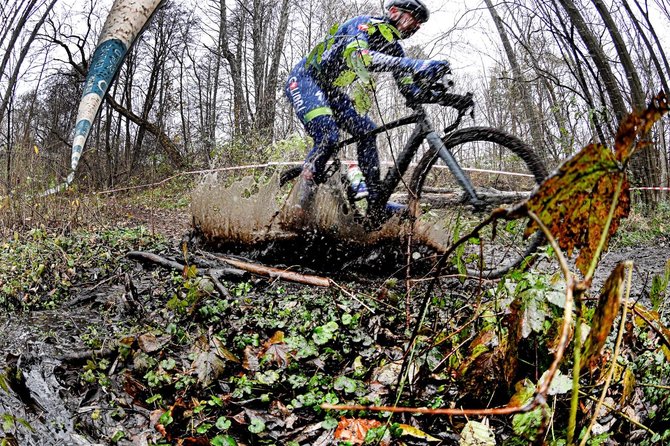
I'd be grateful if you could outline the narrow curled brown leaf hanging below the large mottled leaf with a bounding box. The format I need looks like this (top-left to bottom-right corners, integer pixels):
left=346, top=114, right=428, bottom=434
left=580, top=262, right=626, bottom=368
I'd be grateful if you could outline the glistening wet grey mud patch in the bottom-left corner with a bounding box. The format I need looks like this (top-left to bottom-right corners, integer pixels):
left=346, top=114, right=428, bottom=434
left=0, top=285, right=155, bottom=446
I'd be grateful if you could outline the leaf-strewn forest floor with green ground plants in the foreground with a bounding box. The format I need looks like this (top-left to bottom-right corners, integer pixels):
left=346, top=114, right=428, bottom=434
left=0, top=183, right=670, bottom=446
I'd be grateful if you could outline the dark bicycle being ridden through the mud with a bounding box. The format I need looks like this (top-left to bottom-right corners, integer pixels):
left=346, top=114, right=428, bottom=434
left=280, top=81, right=547, bottom=278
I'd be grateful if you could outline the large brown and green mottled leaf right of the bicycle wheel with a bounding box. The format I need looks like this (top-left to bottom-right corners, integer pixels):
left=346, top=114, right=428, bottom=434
left=526, top=144, right=630, bottom=274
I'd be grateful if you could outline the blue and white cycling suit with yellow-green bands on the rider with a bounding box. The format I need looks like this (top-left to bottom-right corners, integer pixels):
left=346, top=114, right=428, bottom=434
left=285, top=16, right=424, bottom=200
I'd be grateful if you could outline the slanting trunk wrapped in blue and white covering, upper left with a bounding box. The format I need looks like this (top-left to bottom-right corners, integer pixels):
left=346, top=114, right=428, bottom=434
left=44, top=0, right=163, bottom=195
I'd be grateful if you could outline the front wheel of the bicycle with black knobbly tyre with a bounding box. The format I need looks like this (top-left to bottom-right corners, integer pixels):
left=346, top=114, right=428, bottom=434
left=410, top=127, right=547, bottom=278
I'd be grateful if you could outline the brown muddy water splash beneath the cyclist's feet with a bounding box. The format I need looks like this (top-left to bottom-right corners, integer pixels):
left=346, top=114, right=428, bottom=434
left=191, top=172, right=450, bottom=273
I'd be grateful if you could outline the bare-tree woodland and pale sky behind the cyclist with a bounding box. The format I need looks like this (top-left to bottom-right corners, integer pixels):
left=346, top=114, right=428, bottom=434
left=0, top=0, right=670, bottom=206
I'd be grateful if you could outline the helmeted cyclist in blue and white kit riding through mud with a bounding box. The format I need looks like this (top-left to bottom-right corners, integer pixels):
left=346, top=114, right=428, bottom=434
left=285, top=0, right=449, bottom=221
